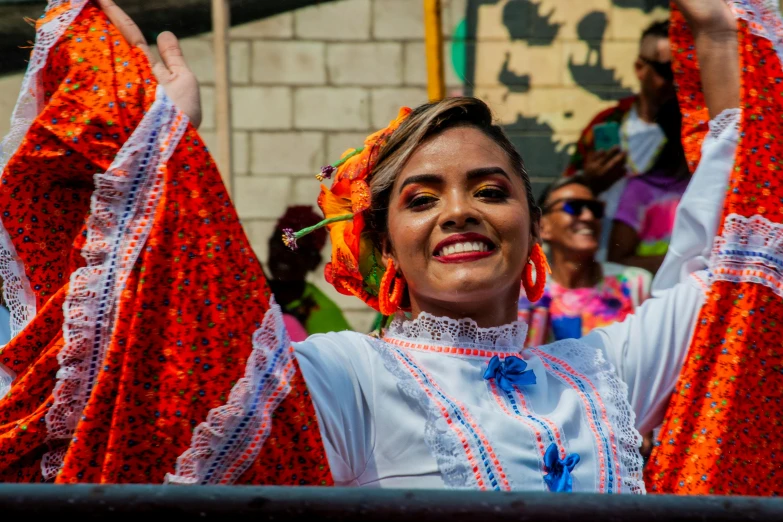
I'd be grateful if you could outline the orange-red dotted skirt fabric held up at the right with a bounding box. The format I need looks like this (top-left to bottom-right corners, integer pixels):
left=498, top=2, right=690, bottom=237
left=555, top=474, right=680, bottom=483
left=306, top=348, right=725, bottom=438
left=646, top=2, right=783, bottom=495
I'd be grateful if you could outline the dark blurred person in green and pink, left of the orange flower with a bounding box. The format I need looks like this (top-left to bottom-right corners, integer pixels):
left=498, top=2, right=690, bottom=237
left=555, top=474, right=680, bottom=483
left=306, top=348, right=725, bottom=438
left=267, top=205, right=351, bottom=342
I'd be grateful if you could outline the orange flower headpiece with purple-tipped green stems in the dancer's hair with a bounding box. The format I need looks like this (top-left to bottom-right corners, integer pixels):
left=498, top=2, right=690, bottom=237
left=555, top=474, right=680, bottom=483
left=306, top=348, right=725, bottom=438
left=283, top=107, right=411, bottom=310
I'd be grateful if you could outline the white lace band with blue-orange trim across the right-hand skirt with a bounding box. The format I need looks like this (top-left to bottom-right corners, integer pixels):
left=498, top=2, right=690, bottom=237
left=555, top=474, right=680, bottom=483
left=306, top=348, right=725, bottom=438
left=710, top=214, right=783, bottom=297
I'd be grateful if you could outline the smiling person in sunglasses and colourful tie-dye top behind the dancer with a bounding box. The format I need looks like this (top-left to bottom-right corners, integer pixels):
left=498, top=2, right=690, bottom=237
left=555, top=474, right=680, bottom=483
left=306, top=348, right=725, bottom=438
left=519, top=176, right=652, bottom=346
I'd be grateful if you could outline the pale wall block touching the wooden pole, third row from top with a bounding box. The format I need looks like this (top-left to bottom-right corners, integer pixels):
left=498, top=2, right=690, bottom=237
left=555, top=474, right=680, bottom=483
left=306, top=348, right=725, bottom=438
left=231, top=87, right=293, bottom=130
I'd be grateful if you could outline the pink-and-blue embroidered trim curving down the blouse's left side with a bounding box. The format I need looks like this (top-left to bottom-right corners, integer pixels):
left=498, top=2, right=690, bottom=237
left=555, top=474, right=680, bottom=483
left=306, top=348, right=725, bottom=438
left=394, top=353, right=511, bottom=491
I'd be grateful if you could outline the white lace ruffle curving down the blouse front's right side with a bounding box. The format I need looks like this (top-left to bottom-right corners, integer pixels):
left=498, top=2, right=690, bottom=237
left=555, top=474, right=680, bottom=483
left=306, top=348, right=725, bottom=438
left=533, top=339, right=645, bottom=494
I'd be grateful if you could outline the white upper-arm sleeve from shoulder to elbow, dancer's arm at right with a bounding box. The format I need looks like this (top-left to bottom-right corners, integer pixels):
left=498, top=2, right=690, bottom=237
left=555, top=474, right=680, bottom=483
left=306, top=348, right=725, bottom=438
left=582, top=273, right=705, bottom=433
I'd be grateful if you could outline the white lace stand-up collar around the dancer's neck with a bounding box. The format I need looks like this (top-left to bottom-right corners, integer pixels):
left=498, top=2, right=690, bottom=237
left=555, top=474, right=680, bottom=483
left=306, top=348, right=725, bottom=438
left=384, top=312, right=527, bottom=355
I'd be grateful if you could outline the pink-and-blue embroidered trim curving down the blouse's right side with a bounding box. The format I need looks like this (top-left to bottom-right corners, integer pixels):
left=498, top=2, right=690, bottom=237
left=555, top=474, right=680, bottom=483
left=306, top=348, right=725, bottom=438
left=534, top=349, right=622, bottom=493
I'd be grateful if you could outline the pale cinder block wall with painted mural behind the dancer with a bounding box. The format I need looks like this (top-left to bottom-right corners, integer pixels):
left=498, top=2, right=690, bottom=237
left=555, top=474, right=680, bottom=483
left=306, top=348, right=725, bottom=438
left=0, top=0, right=666, bottom=330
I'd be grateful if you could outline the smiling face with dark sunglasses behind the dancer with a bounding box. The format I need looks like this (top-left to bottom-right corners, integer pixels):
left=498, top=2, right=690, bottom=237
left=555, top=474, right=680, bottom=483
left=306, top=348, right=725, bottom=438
left=541, top=183, right=601, bottom=256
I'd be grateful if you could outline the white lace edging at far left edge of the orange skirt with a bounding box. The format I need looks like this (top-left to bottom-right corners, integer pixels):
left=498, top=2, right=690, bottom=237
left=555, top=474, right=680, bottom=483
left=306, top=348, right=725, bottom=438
left=0, top=0, right=87, bottom=339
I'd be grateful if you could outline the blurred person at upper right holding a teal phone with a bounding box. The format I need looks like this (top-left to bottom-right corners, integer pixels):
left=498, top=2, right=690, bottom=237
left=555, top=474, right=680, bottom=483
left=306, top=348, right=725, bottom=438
left=565, top=21, right=688, bottom=271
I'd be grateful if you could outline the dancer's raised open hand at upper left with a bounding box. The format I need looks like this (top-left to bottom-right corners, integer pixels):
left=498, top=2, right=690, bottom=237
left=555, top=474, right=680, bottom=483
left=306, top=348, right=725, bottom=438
left=98, top=0, right=201, bottom=129
